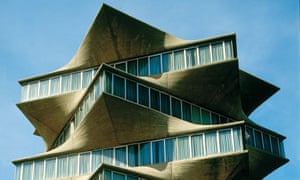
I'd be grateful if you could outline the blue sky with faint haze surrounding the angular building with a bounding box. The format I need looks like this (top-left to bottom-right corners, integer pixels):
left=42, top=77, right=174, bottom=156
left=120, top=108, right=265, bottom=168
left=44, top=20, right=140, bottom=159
left=0, top=0, right=300, bottom=180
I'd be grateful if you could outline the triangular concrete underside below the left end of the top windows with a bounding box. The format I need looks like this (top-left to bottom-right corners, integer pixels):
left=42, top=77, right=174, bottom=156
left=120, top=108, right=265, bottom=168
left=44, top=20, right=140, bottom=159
left=17, top=90, right=84, bottom=150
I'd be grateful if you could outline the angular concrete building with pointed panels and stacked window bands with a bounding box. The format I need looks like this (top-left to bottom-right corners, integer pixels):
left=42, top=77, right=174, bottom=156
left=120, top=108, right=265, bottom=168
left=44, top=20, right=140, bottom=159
left=13, top=5, right=288, bottom=180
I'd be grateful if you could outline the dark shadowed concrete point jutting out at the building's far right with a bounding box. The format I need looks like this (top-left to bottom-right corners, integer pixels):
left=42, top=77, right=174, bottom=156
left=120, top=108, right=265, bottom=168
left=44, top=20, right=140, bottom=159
left=240, top=70, right=279, bottom=115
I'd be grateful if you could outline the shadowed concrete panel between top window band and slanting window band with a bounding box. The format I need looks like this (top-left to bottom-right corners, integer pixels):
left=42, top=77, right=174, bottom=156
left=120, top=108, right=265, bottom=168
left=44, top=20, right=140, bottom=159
left=143, top=60, right=247, bottom=120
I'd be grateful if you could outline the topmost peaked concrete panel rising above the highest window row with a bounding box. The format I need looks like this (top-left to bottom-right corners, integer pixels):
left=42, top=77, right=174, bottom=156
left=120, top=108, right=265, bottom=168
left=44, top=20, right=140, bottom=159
left=60, top=4, right=189, bottom=70
